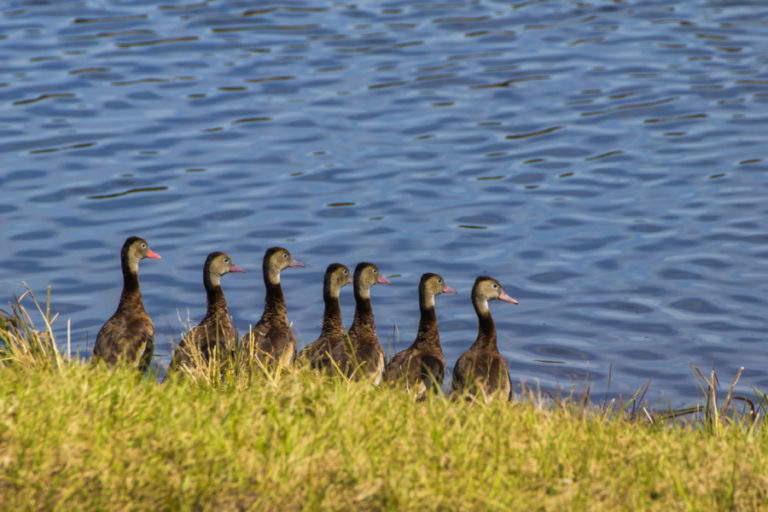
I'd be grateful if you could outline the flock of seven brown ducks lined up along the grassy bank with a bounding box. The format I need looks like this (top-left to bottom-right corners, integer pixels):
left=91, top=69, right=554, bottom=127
left=93, top=236, right=517, bottom=398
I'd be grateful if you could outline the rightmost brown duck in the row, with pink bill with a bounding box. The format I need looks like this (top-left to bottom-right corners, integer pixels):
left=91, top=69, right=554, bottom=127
left=452, top=276, right=517, bottom=400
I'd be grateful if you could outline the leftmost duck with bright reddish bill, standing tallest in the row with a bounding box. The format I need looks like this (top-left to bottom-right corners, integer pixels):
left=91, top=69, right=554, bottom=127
left=93, top=236, right=161, bottom=373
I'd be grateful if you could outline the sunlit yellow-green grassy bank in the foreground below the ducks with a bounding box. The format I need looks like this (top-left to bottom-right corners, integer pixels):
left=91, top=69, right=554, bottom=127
left=0, top=288, right=768, bottom=510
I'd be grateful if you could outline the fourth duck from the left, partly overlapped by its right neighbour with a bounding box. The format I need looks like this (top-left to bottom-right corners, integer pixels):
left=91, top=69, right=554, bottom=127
left=299, top=263, right=352, bottom=368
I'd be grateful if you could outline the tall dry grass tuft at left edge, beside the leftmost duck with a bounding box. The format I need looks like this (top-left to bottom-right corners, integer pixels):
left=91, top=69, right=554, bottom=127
left=0, top=283, right=64, bottom=369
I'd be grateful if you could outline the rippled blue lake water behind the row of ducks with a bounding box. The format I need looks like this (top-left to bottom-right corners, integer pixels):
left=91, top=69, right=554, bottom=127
left=0, top=0, right=768, bottom=405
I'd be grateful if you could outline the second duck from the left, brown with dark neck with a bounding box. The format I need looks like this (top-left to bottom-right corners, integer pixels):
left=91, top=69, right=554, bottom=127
left=170, top=251, right=245, bottom=370
